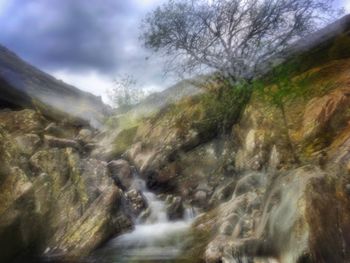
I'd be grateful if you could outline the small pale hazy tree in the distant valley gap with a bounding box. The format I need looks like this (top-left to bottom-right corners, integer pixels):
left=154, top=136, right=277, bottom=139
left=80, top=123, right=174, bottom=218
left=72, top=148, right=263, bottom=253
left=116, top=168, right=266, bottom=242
left=109, top=75, right=145, bottom=109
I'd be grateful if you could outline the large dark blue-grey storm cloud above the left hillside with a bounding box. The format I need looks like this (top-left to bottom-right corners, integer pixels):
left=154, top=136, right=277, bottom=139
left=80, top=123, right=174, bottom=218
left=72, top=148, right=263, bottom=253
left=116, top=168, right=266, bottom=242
left=0, top=0, right=137, bottom=72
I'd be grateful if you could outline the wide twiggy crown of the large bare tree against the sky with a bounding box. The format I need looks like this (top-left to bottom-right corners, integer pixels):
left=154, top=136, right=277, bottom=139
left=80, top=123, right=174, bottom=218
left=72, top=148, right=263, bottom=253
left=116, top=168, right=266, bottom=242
left=141, top=0, right=336, bottom=82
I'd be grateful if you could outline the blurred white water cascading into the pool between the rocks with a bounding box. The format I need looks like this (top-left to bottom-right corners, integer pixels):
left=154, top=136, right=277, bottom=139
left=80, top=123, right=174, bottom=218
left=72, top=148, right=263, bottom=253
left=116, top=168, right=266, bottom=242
left=92, top=173, right=195, bottom=263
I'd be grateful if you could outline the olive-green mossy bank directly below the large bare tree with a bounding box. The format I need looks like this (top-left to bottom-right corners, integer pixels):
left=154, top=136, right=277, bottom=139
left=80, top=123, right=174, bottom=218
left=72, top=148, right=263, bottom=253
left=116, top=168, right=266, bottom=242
left=163, top=77, right=251, bottom=136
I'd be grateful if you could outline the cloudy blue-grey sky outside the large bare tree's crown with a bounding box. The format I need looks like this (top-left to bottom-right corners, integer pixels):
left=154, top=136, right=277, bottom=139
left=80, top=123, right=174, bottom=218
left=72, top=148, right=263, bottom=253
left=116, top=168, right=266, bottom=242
left=0, top=0, right=350, bottom=102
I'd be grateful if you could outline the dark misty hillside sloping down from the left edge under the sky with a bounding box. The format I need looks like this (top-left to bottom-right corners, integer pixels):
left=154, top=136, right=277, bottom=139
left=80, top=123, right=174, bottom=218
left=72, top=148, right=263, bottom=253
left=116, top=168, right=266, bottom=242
left=0, top=45, right=110, bottom=127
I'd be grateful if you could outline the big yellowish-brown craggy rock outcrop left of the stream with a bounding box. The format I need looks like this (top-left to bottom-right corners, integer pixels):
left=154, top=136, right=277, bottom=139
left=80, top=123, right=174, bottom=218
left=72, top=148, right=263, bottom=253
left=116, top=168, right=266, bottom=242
left=0, top=110, right=132, bottom=262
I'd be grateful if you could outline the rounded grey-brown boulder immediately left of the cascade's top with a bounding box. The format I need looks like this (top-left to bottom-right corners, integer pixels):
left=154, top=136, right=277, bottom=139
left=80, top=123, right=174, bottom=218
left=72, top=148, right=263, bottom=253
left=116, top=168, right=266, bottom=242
left=108, top=159, right=134, bottom=190
